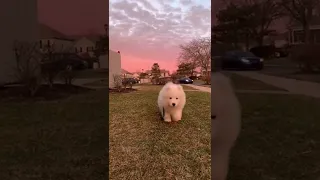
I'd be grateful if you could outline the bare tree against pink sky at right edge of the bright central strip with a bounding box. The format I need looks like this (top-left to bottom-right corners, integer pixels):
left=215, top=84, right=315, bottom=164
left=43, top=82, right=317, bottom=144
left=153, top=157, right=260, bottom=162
left=179, top=38, right=211, bottom=84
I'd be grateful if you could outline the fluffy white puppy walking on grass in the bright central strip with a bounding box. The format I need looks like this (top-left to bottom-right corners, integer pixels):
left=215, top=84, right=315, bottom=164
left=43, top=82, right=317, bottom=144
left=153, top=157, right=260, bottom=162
left=158, top=82, right=186, bottom=122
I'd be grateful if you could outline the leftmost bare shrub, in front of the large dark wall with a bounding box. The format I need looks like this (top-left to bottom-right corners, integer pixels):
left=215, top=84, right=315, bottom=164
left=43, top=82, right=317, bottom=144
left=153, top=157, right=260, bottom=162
left=13, top=41, right=41, bottom=96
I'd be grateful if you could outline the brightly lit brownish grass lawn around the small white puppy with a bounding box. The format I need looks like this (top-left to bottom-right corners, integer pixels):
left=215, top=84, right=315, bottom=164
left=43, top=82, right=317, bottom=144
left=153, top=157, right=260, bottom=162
left=109, top=85, right=211, bottom=180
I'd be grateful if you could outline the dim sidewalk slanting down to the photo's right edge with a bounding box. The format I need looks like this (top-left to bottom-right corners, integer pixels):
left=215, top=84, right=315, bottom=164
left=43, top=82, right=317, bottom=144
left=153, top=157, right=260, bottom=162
left=230, top=71, right=320, bottom=98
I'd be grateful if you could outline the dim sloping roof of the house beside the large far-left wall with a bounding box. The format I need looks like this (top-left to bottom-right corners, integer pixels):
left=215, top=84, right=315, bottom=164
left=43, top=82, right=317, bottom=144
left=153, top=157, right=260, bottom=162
left=39, top=23, right=73, bottom=41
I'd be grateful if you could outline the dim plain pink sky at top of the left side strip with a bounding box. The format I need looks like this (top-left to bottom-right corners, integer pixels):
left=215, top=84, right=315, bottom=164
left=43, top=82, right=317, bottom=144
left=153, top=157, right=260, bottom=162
left=38, top=0, right=109, bottom=35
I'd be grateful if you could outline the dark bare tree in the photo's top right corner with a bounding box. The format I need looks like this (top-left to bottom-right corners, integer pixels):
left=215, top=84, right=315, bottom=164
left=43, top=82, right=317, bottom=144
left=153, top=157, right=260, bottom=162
left=279, top=0, right=320, bottom=44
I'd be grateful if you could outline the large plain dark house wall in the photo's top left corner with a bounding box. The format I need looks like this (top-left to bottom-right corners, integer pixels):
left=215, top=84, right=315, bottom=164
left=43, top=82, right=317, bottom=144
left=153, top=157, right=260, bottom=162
left=0, top=0, right=39, bottom=85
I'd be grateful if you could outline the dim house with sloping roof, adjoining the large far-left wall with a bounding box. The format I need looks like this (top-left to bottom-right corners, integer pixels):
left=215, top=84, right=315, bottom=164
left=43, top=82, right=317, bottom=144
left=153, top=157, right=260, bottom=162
left=39, top=23, right=74, bottom=52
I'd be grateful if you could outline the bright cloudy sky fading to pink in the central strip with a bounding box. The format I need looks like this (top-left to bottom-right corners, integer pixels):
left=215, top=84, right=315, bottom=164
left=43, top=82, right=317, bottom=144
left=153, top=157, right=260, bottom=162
left=109, top=0, right=211, bottom=72
